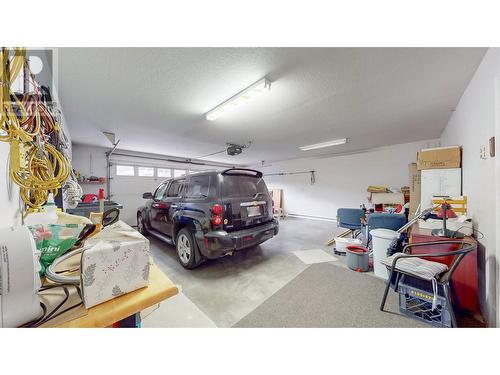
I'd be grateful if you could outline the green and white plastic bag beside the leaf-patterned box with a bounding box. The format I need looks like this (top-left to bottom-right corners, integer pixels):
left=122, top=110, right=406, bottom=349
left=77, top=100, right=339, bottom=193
left=28, top=224, right=84, bottom=276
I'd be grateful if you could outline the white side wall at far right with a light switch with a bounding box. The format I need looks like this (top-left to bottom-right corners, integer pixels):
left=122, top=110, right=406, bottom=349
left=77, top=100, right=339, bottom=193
left=441, top=48, right=500, bottom=326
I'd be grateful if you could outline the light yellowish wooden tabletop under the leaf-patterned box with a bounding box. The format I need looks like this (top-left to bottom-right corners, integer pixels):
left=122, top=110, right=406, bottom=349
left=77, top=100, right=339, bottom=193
left=42, top=264, right=179, bottom=328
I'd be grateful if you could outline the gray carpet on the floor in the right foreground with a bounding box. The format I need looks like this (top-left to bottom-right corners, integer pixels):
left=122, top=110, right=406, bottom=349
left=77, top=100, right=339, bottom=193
left=234, top=263, right=429, bottom=328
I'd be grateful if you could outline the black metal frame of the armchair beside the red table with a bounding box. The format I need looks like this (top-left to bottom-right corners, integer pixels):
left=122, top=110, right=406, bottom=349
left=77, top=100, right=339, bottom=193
left=380, top=240, right=474, bottom=327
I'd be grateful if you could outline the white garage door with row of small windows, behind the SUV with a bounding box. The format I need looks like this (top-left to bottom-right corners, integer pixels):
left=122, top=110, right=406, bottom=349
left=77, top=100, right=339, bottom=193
left=111, top=161, right=193, bottom=225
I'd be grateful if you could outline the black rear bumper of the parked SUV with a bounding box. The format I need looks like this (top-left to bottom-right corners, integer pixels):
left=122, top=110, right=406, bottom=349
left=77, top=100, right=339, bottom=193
left=196, top=219, right=279, bottom=259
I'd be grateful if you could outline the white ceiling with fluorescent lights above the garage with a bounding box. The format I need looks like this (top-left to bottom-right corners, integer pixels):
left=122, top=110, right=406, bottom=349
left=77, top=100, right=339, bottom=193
left=58, top=48, right=486, bottom=164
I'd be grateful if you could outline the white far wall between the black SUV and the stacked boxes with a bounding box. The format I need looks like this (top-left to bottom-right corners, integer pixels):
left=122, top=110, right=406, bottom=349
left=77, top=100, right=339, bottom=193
left=256, top=140, right=439, bottom=219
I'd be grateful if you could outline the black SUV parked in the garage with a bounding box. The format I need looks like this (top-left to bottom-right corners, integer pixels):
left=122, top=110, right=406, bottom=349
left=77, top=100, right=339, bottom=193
left=137, top=168, right=279, bottom=268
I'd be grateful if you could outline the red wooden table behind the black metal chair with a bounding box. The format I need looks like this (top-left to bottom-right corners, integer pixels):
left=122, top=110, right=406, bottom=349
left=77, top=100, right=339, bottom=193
left=410, top=224, right=481, bottom=315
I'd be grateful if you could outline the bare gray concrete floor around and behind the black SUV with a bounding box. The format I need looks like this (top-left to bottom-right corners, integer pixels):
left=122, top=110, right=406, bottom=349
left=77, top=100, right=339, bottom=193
left=143, top=217, right=345, bottom=327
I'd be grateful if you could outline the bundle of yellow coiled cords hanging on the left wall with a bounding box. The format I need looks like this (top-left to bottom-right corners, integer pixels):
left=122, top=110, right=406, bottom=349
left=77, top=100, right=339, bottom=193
left=0, top=48, right=71, bottom=211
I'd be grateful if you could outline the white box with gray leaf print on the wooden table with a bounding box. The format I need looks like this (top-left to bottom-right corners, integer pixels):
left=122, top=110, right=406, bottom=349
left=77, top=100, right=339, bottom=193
left=81, top=221, right=150, bottom=308
